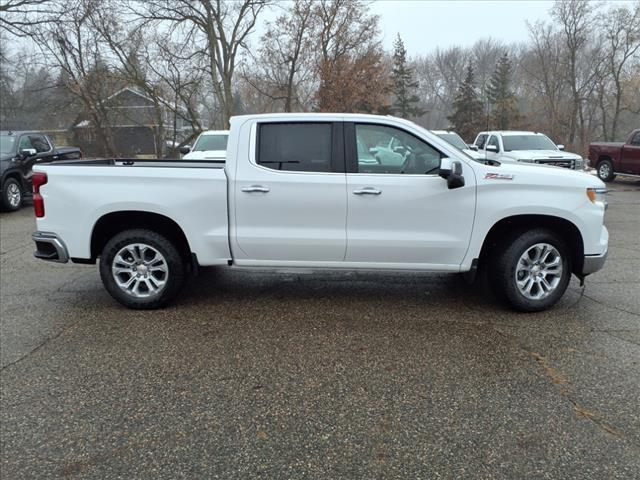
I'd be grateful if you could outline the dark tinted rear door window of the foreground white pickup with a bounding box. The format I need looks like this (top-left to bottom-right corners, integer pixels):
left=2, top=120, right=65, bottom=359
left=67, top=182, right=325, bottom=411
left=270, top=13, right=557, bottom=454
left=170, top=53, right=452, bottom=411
left=257, top=123, right=332, bottom=172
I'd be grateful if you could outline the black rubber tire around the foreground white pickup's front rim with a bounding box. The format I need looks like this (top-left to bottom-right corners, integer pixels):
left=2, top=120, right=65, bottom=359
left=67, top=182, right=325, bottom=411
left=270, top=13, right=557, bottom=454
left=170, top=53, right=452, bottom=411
left=488, top=228, right=571, bottom=312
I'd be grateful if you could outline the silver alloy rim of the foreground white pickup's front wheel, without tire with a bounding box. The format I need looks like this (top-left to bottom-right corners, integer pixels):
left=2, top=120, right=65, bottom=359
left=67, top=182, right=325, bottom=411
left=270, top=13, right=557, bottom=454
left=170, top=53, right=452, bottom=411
left=515, top=243, right=562, bottom=300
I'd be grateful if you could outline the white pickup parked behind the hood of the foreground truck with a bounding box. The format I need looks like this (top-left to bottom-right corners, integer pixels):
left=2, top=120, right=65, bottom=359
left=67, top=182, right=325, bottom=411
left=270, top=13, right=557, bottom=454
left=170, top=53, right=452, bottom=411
left=473, top=130, right=585, bottom=170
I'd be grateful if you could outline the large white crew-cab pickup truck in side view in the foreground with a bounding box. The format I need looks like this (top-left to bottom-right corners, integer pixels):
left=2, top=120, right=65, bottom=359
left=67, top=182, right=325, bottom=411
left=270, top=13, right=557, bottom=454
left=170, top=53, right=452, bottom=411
left=33, top=113, right=609, bottom=311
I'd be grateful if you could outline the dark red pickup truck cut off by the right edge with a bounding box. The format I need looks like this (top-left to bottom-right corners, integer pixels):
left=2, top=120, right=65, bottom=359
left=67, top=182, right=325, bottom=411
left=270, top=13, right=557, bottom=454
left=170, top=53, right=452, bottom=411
left=589, top=129, right=640, bottom=182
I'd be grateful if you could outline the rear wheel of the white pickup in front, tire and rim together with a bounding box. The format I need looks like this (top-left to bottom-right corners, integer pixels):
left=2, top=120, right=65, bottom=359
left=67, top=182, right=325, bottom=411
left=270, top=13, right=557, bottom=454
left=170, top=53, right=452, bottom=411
left=100, top=229, right=186, bottom=309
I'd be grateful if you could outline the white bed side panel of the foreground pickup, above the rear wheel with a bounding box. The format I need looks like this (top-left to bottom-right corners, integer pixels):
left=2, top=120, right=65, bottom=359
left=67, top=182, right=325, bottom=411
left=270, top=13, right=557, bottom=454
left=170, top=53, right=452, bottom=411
left=34, top=158, right=230, bottom=265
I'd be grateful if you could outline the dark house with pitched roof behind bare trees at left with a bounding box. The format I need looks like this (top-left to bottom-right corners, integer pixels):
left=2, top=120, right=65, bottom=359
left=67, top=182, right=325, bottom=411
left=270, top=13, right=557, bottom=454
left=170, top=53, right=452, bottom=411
left=71, top=87, right=193, bottom=157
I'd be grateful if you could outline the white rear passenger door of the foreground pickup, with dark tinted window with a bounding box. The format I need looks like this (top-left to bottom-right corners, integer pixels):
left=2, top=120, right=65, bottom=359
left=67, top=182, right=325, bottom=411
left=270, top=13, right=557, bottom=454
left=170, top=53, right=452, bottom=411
left=232, top=121, right=347, bottom=265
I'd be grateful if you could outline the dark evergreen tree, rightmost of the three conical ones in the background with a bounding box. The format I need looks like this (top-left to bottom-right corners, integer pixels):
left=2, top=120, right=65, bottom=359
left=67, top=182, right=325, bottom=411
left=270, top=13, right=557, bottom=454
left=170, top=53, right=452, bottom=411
left=487, top=53, right=520, bottom=130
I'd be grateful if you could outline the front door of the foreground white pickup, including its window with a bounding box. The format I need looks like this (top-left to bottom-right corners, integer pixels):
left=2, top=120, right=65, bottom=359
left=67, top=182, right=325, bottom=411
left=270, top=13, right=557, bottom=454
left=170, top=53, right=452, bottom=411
left=345, top=123, right=476, bottom=270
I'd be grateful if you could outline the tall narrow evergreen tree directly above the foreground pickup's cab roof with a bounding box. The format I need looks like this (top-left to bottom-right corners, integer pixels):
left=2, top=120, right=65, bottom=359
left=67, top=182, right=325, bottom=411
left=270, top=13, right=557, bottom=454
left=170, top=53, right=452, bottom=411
left=391, top=34, right=425, bottom=118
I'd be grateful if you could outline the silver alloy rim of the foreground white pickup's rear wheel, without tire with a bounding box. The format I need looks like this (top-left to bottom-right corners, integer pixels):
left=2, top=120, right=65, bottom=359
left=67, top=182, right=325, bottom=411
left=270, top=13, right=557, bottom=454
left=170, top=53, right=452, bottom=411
left=111, top=243, right=169, bottom=298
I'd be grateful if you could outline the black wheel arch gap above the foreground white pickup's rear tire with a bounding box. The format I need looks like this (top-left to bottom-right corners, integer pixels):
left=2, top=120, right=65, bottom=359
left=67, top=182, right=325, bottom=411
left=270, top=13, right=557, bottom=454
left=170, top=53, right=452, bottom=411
left=91, top=210, right=192, bottom=263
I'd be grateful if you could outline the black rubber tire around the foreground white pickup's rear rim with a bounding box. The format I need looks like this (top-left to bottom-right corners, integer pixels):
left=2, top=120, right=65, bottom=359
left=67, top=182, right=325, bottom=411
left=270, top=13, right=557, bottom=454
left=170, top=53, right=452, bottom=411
left=100, top=229, right=187, bottom=309
